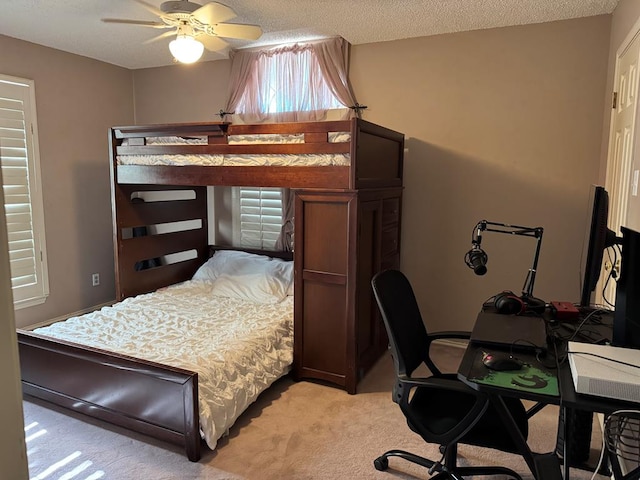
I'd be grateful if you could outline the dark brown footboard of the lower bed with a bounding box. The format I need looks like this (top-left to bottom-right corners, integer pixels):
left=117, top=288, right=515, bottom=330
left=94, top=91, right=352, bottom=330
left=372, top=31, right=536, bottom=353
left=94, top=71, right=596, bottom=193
left=18, top=330, right=201, bottom=462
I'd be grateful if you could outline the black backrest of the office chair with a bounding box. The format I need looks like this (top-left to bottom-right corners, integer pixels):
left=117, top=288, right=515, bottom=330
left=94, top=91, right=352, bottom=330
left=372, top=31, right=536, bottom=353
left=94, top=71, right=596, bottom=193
left=371, top=270, right=429, bottom=376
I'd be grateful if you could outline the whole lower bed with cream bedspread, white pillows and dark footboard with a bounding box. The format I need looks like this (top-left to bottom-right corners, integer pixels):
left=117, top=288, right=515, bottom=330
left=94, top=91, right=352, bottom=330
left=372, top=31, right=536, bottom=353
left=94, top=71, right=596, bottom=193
left=18, top=250, right=293, bottom=461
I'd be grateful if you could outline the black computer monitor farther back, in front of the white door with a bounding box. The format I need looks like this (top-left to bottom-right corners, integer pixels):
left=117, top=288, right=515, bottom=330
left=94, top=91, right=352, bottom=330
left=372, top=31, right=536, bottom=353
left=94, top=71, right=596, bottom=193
left=580, top=185, right=618, bottom=308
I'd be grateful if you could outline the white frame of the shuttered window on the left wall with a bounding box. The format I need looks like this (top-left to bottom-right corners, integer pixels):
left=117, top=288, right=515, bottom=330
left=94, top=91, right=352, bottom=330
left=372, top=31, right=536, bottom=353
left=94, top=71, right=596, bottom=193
left=0, top=74, right=50, bottom=309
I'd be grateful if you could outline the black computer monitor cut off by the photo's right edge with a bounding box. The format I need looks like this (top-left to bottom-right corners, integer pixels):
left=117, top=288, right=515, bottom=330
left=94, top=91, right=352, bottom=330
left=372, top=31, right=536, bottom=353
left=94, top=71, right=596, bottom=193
left=612, top=227, right=640, bottom=349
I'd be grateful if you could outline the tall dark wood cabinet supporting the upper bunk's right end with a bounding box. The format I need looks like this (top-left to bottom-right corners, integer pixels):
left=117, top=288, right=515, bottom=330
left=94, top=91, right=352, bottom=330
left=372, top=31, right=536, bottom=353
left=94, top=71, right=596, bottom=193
left=294, top=187, right=402, bottom=393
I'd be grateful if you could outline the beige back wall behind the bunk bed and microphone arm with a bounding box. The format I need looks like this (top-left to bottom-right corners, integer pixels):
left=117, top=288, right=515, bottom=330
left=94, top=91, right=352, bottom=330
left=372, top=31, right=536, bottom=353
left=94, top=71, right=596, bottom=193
left=134, top=16, right=611, bottom=329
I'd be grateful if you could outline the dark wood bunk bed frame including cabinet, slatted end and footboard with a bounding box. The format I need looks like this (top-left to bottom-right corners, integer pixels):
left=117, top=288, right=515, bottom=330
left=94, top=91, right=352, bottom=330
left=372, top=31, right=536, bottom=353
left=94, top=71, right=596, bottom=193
left=18, top=119, right=404, bottom=461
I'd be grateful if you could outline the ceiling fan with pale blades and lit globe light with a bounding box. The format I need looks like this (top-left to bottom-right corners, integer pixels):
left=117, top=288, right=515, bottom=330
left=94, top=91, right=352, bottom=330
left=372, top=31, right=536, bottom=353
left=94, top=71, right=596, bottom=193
left=102, top=0, right=262, bottom=63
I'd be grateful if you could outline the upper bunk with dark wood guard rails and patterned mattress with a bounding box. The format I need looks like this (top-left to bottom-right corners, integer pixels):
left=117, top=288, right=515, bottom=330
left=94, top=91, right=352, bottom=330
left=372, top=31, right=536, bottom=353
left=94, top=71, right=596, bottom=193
left=110, top=119, right=404, bottom=190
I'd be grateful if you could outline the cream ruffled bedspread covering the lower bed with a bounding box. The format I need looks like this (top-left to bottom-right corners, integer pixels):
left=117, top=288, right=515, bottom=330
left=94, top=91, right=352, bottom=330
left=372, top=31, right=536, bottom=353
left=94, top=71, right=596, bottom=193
left=34, top=280, right=293, bottom=449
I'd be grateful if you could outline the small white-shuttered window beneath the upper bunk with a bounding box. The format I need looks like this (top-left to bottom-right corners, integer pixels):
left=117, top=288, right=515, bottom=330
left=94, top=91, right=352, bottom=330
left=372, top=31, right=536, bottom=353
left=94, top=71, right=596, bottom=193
left=233, top=187, right=282, bottom=250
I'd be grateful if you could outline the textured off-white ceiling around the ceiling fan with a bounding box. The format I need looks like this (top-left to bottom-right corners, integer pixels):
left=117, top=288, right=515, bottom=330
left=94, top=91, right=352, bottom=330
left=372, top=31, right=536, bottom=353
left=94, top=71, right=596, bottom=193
left=0, top=0, right=618, bottom=69
